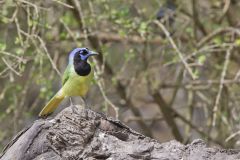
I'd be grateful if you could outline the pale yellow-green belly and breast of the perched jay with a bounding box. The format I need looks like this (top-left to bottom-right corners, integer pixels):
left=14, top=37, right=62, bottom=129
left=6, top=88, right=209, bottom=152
left=62, top=69, right=93, bottom=97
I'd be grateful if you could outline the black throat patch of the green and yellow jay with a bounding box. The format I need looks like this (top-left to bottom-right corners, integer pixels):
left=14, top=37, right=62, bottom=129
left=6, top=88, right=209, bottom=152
left=73, top=57, right=91, bottom=76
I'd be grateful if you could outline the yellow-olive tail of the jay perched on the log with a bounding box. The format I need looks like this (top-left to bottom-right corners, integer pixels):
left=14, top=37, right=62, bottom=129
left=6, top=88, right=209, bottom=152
left=39, top=90, right=65, bottom=117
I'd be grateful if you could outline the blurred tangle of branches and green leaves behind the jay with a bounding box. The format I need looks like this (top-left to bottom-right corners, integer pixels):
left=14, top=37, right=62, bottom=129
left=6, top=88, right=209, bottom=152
left=0, top=0, right=240, bottom=148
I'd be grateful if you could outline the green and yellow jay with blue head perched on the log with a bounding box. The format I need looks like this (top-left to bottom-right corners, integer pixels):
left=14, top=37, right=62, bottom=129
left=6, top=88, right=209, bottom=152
left=39, top=48, right=98, bottom=117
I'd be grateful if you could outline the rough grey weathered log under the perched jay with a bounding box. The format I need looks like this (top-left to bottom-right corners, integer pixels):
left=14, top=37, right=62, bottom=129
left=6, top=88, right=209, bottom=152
left=0, top=106, right=240, bottom=160
